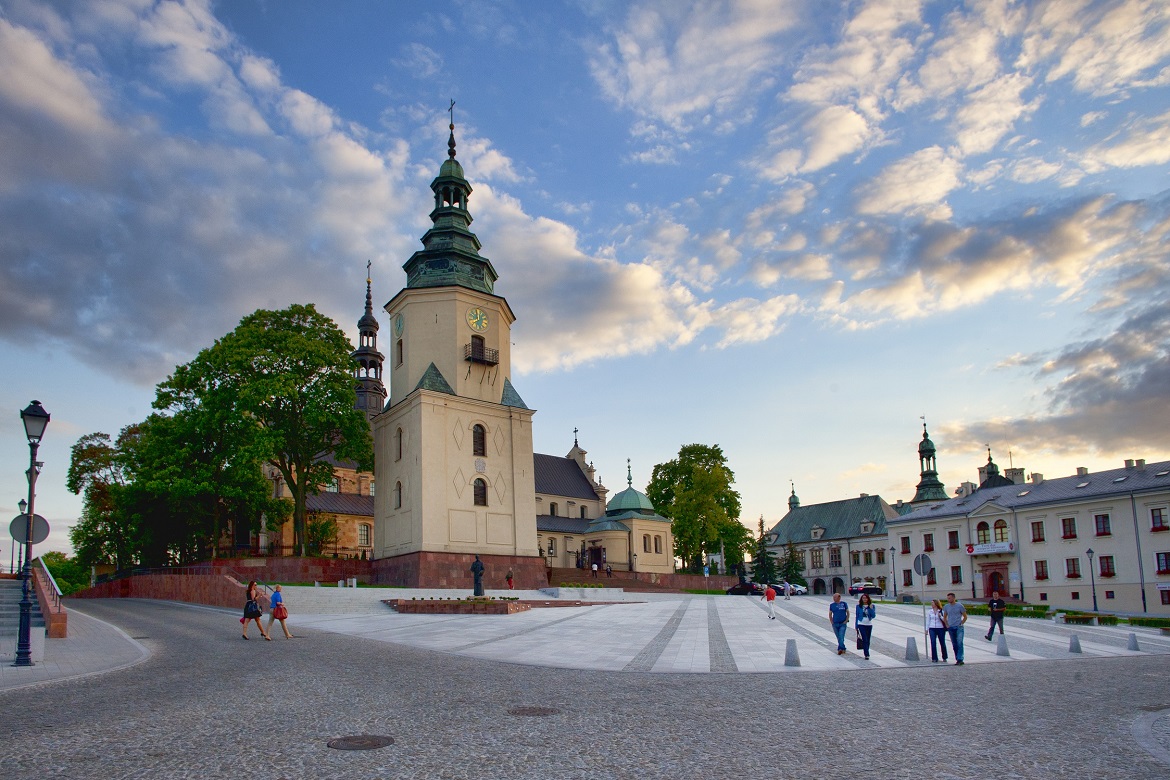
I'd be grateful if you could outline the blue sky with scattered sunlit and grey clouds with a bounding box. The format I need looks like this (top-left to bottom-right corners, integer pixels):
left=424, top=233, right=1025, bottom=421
left=0, top=0, right=1170, bottom=554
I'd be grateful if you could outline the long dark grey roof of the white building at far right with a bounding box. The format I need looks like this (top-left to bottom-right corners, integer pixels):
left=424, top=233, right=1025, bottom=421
left=890, top=461, right=1170, bottom=525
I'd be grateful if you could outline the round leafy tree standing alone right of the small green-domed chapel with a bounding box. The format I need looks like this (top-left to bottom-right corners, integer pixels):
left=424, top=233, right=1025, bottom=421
left=646, top=444, right=751, bottom=571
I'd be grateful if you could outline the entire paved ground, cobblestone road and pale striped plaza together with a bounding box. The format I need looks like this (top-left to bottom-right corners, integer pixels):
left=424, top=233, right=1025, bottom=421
left=0, top=591, right=1170, bottom=780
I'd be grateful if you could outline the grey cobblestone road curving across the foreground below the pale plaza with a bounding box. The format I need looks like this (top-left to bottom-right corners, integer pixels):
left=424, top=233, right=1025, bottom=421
left=0, top=601, right=1170, bottom=780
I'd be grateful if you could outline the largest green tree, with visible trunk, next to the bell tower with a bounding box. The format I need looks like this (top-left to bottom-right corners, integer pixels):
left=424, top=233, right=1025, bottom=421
left=154, top=304, right=373, bottom=554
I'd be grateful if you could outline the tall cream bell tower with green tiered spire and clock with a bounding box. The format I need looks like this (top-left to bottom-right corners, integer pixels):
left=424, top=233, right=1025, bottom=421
left=374, top=112, right=544, bottom=587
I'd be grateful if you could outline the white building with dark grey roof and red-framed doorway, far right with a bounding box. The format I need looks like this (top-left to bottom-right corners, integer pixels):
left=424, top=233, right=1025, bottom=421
left=886, top=458, right=1170, bottom=615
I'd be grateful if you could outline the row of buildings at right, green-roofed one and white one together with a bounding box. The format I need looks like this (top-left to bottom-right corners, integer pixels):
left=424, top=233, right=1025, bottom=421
left=770, top=430, right=1170, bottom=616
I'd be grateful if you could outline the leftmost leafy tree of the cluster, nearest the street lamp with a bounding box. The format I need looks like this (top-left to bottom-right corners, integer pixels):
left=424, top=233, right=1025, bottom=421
left=66, top=426, right=137, bottom=570
